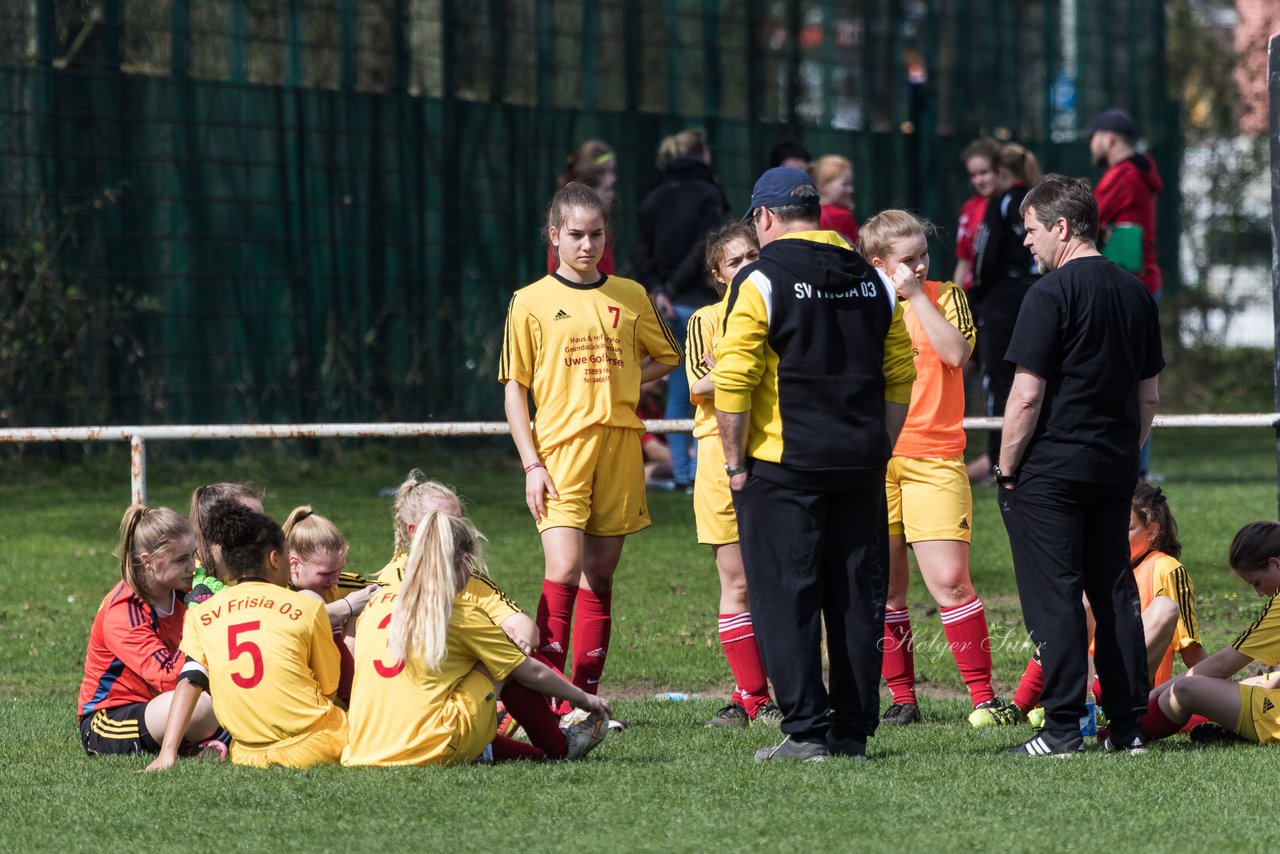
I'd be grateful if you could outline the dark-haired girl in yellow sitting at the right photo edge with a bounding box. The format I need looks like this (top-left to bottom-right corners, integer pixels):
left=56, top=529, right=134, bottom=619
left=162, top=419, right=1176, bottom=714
left=1142, top=521, right=1280, bottom=744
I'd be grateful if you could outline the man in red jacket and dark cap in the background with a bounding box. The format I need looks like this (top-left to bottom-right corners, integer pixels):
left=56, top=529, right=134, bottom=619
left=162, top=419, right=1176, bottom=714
left=1083, top=108, right=1165, bottom=300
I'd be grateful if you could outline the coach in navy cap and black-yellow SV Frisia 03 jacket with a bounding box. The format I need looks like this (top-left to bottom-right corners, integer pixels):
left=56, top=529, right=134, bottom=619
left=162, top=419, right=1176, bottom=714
left=712, top=166, right=915, bottom=761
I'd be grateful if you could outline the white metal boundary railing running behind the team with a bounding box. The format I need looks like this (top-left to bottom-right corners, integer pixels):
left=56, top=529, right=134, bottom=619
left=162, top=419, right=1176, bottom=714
left=0, top=412, right=1280, bottom=503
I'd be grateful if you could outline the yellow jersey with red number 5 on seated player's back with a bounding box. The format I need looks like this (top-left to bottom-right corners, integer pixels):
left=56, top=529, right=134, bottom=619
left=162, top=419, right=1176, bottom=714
left=182, top=581, right=339, bottom=746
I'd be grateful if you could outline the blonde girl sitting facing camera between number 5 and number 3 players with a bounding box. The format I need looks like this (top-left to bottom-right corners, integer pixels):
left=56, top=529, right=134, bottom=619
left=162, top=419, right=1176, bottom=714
left=284, top=507, right=378, bottom=702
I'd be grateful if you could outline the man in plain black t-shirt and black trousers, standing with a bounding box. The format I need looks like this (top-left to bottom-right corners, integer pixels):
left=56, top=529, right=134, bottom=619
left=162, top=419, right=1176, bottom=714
left=995, top=175, right=1165, bottom=755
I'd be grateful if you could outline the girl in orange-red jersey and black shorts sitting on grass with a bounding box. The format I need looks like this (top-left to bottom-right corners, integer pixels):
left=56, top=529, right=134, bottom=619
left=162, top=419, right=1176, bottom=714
left=79, top=504, right=225, bottom=757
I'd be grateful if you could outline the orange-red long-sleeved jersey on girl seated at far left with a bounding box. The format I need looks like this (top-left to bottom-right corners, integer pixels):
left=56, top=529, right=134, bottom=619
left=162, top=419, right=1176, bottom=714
left=79, top=581, right=187, bottom=714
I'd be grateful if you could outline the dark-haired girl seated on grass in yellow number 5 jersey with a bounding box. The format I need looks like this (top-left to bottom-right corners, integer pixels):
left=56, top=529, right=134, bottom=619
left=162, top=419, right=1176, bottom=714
left=147, top=501, right=347, bottom=771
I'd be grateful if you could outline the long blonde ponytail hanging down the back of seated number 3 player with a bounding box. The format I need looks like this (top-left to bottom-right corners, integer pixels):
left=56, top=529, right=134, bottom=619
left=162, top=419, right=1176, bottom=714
left=389, top=508, right=484, bottom=672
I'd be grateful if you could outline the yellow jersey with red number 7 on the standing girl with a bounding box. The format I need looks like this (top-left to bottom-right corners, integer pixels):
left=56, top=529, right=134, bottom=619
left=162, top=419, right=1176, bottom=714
left=498, top=274, right=680, bottom=452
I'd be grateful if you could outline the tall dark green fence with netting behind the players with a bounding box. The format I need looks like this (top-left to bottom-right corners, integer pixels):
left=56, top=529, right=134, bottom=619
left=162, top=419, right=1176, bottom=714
left=0, top=0, right=1180, bottom=425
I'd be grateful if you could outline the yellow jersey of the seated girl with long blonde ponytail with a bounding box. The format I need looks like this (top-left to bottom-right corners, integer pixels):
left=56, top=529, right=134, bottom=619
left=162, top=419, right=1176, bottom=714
left=342, top=589, right=525, bottom=766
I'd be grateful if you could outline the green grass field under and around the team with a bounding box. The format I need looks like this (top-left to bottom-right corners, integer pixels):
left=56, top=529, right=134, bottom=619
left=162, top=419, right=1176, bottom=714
left=0, top=430, right=1280, bottom=851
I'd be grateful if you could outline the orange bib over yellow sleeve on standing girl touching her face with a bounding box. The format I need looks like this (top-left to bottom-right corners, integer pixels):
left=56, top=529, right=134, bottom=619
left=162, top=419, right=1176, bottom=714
left=893, top=282, right=977, bottom=458
